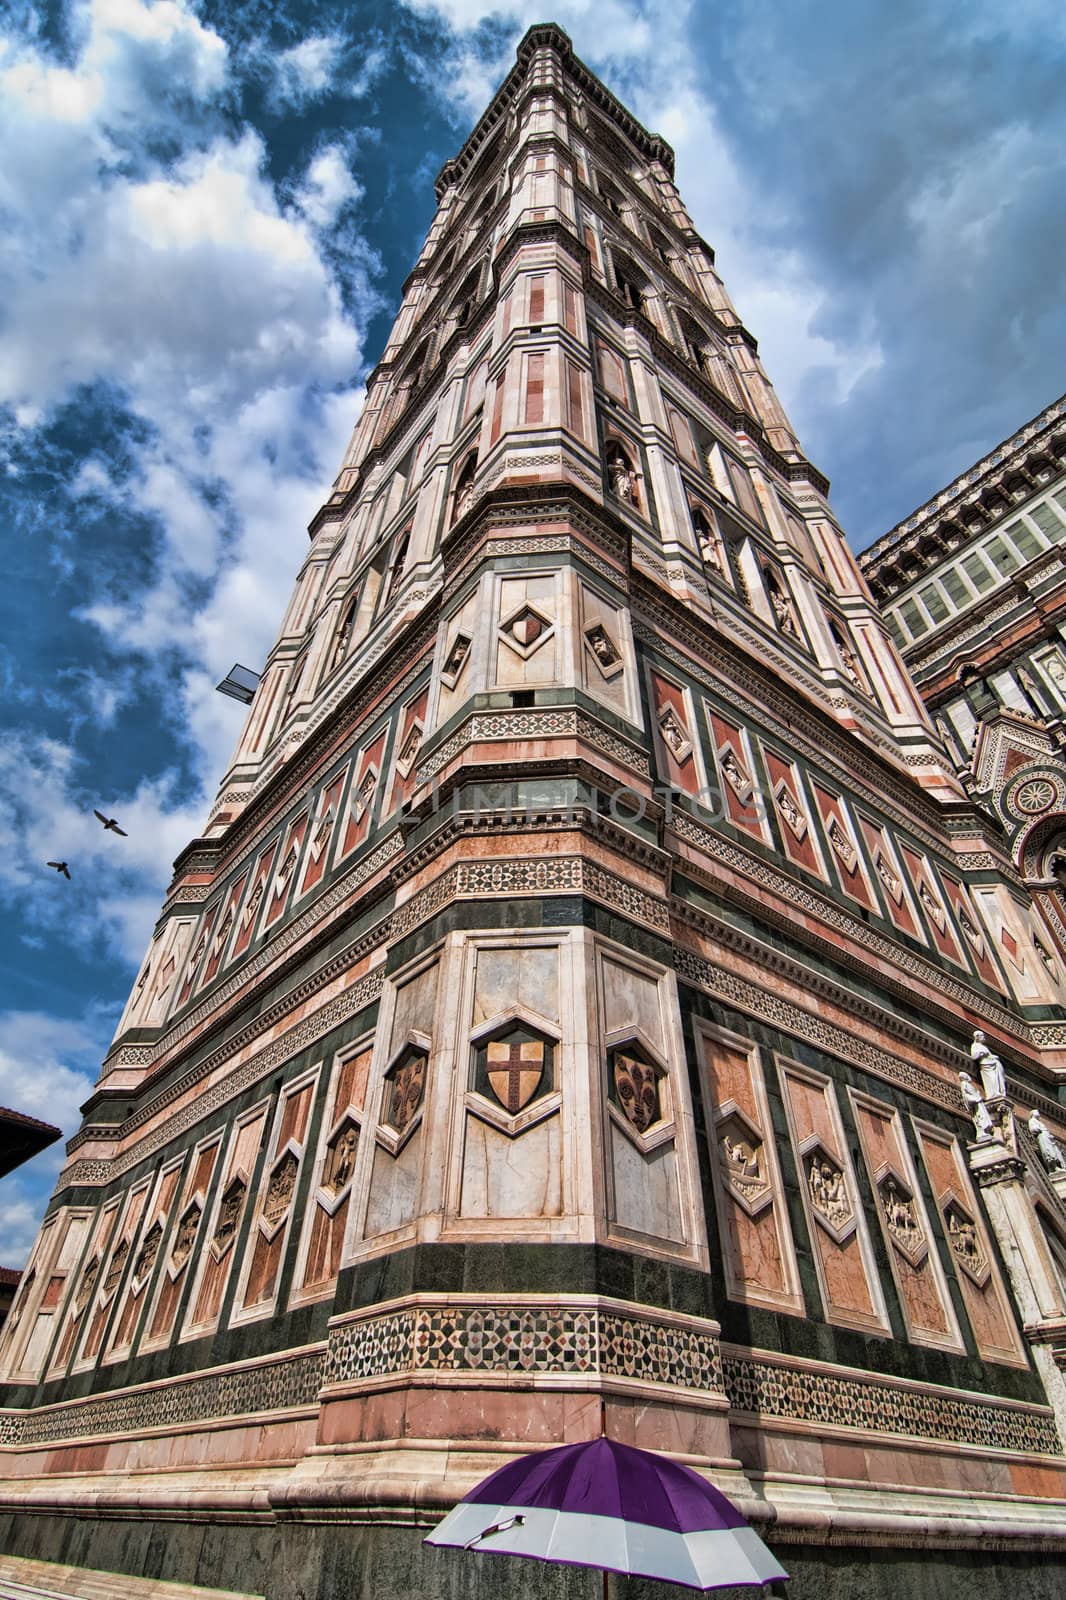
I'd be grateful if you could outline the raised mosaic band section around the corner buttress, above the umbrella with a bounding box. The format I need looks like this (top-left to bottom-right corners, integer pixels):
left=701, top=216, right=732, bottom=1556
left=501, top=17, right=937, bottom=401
left=325, top=1301, right=722, bottom=1395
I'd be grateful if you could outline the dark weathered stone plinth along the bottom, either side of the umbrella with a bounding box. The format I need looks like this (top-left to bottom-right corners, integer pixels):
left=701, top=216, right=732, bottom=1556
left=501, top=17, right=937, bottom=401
left=0, top=1506, right=1063, bottom=1600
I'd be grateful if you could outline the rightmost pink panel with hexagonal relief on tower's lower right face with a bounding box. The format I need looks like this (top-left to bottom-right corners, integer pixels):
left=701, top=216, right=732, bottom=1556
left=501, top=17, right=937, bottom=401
left=914, top=1117, right=1026, bottom=1366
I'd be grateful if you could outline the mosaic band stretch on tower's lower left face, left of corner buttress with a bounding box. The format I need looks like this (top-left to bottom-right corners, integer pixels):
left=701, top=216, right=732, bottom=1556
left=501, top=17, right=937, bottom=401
left=0, top=1350, right=327, bottom=1445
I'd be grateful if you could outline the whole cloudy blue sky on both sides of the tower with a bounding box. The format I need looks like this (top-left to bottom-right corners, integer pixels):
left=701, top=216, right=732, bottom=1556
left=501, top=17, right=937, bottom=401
left=0, top=0, right=1066, bottom=1266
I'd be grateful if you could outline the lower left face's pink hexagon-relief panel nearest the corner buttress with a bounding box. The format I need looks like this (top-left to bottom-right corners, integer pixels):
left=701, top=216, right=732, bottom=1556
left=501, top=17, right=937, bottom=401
left=291, top=1040, right=373, bottom=1304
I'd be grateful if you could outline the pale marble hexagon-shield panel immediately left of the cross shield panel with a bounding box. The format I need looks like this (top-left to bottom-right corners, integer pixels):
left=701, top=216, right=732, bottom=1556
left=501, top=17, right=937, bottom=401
left=358, top=954, right=440, bottom=1259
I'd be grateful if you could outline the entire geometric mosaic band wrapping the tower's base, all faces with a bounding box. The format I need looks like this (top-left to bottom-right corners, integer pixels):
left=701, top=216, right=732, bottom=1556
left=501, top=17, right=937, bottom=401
left=0, top=1318, right=1063, bottom=1458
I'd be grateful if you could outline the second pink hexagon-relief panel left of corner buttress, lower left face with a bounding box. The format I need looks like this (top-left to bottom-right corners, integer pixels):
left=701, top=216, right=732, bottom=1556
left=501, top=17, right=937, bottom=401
left=230, top=1067, right=319, bottom=1326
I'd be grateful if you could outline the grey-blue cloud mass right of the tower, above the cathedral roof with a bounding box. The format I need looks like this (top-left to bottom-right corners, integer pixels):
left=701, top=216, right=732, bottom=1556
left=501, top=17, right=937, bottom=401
left=695, top=0, right=1066, bottom=544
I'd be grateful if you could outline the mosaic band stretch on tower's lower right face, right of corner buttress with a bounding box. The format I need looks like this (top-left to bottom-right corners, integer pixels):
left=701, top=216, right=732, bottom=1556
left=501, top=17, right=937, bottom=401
left=722, top=1355, right=1063, bottom=1456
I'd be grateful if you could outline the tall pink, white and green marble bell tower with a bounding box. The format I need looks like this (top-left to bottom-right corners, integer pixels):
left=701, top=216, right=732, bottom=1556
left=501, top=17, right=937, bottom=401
left=0, top=26, right=1066, bottom=1597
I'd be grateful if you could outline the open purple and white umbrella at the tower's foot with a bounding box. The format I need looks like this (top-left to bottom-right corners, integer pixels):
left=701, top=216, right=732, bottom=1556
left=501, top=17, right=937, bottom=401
left=426, top=1438, right=787, bottom=1589
